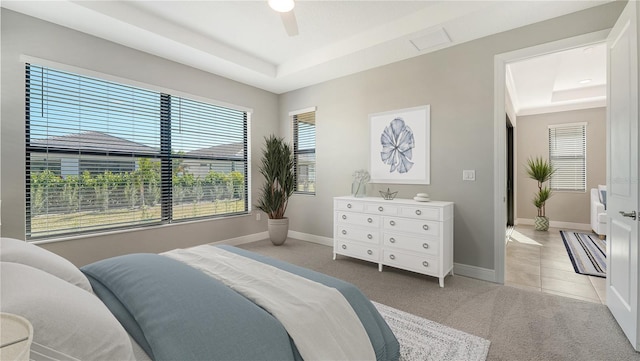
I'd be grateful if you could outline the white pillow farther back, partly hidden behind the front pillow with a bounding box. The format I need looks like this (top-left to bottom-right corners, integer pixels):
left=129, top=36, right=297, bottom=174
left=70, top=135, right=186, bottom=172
left=0, top=237, right=93, bottom=293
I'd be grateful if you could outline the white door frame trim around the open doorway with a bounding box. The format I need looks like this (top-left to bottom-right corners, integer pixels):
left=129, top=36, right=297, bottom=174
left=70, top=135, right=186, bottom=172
left=493, top=29, right=611, bottom=284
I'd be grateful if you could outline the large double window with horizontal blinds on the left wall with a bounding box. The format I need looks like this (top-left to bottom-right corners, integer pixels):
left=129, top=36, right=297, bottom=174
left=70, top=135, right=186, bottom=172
left=26, top=64, right=249, bottom=239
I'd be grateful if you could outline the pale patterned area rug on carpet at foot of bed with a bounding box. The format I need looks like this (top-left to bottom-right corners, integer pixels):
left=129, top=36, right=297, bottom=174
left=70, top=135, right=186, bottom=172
left=373, top=302, right=490, bottom=361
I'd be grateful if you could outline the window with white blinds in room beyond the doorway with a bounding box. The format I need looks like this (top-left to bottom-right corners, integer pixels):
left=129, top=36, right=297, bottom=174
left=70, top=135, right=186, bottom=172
left=549, top=123, right=587, bottom=192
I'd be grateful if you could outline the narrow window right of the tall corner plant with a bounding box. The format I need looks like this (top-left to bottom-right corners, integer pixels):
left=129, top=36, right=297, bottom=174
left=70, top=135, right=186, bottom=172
left=290, top=108, right=316, bottom=194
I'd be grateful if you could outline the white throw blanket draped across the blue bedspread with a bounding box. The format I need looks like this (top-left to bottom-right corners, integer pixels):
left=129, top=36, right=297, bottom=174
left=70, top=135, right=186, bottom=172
left=163, top=245, right=376, bottom=361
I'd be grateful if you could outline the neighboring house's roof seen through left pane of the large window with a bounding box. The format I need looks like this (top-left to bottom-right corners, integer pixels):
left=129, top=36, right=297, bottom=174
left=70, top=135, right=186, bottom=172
left=31, top=131, right=158, bottom=154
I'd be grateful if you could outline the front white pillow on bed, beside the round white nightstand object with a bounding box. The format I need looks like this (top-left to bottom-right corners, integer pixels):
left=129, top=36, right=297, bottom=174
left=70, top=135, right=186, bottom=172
left=0, top=262, right=135, bottom=360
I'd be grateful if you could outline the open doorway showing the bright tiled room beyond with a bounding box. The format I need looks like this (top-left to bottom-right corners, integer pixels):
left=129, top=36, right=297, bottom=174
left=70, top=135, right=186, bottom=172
left=505, top=39, right=606, bottom=303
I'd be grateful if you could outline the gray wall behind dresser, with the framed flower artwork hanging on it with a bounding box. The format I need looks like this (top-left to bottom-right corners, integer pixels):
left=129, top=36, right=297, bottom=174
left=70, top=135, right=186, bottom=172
left=280, top=2, right=624, bottom=269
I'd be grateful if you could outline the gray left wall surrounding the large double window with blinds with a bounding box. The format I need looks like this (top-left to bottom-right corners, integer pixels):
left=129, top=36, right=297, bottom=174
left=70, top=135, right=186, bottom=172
left=0, top=9, right=279, bottom=265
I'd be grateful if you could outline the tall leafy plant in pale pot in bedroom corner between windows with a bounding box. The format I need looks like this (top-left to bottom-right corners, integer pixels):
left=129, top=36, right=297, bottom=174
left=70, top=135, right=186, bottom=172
left=256, top=135, right=295, bottom=246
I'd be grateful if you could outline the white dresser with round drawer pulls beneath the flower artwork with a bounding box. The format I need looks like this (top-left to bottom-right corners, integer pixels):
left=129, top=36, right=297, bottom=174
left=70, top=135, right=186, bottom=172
left=333, top=197, right=453, bottom=287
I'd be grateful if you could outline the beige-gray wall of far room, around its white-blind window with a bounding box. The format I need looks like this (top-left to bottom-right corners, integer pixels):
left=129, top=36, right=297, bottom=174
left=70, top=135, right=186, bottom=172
left=515, top=108, right=607, bottom=224
